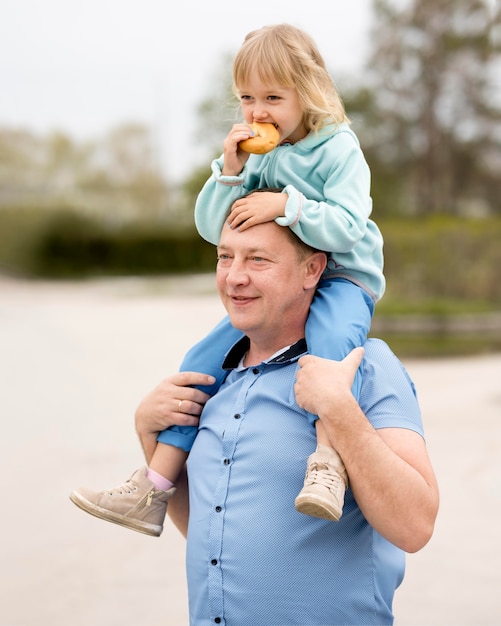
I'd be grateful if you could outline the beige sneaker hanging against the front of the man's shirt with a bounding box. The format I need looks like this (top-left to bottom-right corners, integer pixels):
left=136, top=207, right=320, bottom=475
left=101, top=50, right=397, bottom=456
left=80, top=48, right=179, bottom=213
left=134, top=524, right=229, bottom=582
left=294, top=446, right=348, bottom=522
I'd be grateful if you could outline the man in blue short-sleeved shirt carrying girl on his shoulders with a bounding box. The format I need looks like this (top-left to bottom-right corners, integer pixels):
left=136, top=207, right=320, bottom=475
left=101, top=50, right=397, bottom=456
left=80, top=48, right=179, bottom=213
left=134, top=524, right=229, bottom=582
left=136, top=217, right=438, bottom=626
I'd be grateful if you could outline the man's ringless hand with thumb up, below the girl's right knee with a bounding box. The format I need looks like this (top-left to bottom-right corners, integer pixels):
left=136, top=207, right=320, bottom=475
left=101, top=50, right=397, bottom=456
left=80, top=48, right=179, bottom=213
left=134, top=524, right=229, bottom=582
left=294, top=348, right=364, bottom=415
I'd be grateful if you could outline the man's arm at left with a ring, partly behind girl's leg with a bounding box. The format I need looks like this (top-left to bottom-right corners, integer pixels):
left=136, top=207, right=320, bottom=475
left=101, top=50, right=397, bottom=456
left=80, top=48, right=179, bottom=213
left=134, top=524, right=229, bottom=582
left=135, top=372, right=215, bottom=536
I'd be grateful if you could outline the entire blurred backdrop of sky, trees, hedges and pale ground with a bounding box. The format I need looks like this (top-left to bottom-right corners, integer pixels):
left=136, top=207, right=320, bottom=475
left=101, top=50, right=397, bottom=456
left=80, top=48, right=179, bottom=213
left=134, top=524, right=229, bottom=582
left=0, top=0, right=501, bottom=626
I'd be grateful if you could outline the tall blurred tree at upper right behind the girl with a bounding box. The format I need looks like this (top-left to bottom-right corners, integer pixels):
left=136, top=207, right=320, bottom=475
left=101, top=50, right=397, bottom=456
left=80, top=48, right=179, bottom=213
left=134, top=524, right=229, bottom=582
left=345, top=0, right=501, bottom=214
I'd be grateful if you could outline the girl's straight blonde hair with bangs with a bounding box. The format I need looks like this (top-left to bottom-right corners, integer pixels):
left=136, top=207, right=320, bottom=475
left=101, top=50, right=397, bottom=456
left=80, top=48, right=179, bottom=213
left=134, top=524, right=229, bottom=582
left=233, top=24, right=349, bottom=131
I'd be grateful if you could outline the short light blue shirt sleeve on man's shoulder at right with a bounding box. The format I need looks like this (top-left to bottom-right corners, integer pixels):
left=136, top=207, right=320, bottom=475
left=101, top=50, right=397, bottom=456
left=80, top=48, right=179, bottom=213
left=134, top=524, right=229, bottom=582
left=360, top=339, right=424, bottom=437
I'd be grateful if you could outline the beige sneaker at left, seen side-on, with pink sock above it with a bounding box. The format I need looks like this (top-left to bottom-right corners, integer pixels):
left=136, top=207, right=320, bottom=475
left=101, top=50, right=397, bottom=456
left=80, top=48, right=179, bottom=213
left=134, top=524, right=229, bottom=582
left=70, top=467, right=176, bottom=537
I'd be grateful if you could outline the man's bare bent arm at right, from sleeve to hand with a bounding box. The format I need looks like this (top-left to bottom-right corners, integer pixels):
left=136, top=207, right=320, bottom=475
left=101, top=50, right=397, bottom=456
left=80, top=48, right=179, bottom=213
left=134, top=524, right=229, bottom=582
left=295, top=348, right=439, bottom=552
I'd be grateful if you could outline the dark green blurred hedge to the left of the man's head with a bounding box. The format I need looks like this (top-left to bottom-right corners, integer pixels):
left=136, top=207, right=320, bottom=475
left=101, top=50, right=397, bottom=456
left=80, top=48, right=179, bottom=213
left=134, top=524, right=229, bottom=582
left=0, top=210, right=216, bottom=278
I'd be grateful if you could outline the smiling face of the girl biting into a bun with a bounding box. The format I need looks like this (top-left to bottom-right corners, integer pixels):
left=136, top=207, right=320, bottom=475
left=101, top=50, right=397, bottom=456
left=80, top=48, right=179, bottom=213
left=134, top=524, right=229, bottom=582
left=239, top=74, right=308, bottom=143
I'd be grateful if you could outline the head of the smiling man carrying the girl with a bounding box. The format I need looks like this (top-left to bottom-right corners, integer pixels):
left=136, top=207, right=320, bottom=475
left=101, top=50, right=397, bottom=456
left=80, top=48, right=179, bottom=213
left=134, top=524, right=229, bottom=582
left=216, top=214, right=326, bottom=358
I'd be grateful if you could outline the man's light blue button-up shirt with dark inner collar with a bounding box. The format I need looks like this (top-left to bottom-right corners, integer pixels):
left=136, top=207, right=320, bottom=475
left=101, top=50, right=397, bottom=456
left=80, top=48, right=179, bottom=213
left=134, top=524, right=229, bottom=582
left=187, top=339, right=423, bottom=626
